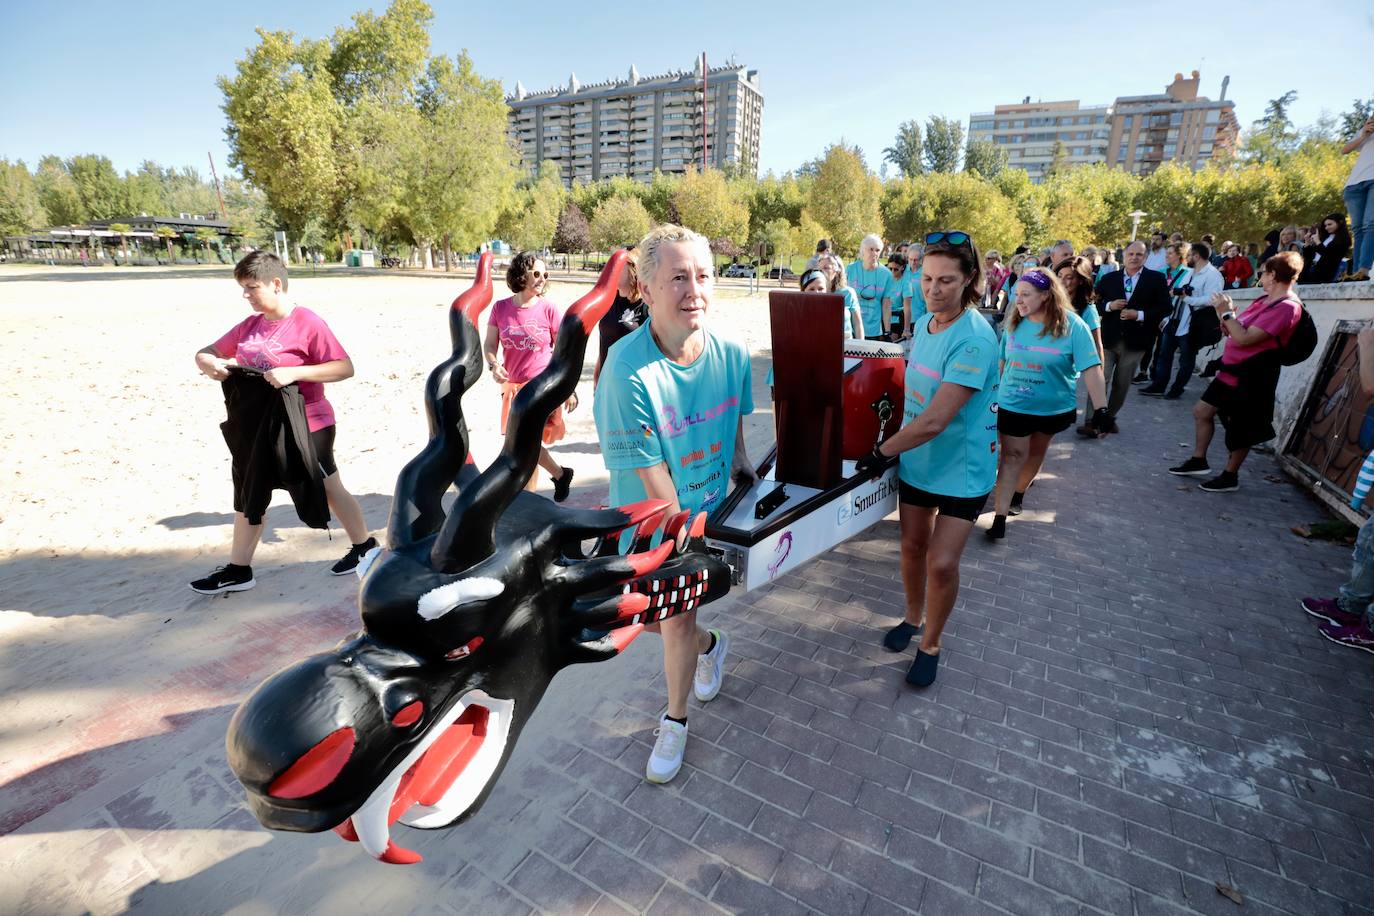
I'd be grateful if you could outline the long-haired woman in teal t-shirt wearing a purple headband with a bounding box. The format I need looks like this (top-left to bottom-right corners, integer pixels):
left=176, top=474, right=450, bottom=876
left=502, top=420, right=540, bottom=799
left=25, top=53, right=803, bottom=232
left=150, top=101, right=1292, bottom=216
left=988, top=268, right=1107, bottom=538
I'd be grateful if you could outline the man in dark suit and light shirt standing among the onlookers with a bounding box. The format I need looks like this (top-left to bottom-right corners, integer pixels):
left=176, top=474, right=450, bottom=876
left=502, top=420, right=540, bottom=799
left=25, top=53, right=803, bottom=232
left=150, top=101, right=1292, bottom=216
left=1098, top=242, right=1171, bottom=433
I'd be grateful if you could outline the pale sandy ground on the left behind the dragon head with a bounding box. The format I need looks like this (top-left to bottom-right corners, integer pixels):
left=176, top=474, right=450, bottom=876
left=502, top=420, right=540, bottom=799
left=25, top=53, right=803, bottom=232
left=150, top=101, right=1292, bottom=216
left=0, top=259, right=772, bottom=834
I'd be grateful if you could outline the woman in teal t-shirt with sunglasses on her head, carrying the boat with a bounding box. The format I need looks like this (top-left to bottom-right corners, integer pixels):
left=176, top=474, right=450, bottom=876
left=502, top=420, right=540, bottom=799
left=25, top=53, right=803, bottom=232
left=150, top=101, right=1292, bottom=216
left=857, top=231, right=998, bottom=687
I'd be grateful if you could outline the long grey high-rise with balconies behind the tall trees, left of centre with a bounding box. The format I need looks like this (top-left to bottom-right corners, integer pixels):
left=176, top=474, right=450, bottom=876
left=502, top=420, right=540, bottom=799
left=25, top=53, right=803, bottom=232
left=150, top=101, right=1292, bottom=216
left=506, top=60, right=764, bottom=187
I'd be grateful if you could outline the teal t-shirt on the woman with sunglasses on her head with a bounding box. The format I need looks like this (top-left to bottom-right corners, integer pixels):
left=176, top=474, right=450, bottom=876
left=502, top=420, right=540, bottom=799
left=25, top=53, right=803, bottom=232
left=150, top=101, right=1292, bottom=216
left=899, top=309, right=998, bottom=497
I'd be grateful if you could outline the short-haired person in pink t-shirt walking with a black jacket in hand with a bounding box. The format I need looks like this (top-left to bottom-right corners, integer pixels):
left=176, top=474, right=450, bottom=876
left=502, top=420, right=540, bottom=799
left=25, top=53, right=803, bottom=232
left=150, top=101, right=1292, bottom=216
left=191, top=251, right=376, bottom=595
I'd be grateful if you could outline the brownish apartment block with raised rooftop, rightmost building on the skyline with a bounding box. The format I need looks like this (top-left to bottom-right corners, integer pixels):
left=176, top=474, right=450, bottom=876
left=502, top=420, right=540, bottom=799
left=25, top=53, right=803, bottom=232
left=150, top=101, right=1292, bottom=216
left=1107, top=70, right=1241, bottom=174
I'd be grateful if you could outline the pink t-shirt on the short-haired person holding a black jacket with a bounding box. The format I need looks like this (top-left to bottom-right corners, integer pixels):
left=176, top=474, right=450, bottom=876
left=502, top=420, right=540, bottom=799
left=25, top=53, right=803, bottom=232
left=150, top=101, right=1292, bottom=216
left=214, top=306, right=348, bottom=433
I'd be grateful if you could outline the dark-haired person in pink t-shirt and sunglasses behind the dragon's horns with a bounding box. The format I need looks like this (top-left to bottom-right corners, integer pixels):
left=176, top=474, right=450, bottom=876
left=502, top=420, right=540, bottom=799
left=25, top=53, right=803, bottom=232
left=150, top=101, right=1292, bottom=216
left=482, top=251, right=577, bottom=503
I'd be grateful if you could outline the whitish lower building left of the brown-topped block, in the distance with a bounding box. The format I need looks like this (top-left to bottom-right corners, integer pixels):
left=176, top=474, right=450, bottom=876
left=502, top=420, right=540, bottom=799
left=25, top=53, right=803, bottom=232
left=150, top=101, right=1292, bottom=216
left=969, top=98, right=1110, bottom=183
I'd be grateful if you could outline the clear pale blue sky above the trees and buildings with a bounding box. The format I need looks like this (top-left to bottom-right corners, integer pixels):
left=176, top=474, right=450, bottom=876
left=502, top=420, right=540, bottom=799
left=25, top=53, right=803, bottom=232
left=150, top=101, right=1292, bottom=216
left=0, top=0, right=1374, bottom=181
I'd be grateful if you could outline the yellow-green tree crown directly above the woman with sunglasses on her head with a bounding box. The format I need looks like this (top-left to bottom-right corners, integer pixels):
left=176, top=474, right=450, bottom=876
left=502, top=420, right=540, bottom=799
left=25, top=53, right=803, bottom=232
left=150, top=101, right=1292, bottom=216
left=882, top=172, right=1024, bottom=251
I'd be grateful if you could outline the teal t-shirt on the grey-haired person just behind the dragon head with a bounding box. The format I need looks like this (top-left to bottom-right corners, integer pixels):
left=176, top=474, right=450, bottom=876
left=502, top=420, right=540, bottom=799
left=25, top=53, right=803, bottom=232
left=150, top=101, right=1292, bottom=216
left=592, top=324, right=754, bottom=512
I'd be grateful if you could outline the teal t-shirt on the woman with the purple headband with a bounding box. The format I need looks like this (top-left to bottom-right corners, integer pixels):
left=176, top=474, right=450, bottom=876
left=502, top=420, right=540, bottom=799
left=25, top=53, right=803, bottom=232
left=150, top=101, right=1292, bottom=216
left=998, top=312, right=1102, bottom=416
